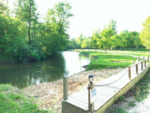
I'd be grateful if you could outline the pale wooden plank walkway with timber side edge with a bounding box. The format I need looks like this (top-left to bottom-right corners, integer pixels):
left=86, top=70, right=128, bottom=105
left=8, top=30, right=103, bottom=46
left=62, top=59, right=149, bottom=113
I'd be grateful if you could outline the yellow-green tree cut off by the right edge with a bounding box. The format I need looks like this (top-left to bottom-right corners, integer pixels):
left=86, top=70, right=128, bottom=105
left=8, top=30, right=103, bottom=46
left=140, top=16, right=150, bottom=49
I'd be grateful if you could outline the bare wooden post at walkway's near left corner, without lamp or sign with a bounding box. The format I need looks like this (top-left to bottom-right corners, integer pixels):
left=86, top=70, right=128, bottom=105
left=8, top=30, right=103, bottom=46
left=63, top=77, right=68, bottom=100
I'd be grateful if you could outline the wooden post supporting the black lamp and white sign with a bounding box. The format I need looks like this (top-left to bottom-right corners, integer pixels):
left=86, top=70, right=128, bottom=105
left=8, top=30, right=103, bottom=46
left=88, top=84, right=94, bottom=113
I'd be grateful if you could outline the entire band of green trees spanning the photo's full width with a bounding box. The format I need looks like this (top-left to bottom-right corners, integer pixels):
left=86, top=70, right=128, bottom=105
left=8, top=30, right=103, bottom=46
left=0, top=0, right=150, bottom=61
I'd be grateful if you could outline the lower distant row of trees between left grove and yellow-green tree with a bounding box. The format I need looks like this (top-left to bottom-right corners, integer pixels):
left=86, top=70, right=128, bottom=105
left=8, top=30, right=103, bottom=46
left=68, top=19, right=142, bottom=51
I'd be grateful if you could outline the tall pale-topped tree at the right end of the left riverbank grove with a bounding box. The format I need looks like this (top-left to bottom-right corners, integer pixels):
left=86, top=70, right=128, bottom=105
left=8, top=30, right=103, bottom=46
left=43, top=2, right=73, bottom=54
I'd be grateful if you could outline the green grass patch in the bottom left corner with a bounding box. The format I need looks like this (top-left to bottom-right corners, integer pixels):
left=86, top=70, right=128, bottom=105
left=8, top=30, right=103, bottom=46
left=0, top=84, right=56, bottom=113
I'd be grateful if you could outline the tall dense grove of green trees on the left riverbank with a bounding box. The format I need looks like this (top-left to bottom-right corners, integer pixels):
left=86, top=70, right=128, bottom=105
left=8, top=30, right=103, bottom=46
left=0, top=0, right=73, bottom=61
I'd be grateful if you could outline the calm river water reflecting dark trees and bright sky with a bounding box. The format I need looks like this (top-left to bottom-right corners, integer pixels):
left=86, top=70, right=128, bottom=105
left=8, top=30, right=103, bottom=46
left=0, top=51, right=90, bottom=88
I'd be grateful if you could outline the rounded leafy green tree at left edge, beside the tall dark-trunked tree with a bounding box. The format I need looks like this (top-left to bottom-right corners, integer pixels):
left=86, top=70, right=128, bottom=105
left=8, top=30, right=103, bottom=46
left=0, top=15, right=27, bottom=57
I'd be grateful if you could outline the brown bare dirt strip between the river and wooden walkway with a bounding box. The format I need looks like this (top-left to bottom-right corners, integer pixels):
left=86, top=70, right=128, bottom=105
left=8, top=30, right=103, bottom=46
left=23, top=68, right=124, bottom=111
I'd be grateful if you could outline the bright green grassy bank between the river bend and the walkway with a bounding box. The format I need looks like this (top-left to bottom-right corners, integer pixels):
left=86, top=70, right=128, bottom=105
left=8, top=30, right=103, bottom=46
left=78, top=50, right=137, bottom=70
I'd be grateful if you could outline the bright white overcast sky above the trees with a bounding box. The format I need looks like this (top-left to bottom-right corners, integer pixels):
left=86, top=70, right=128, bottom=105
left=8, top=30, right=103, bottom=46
left=9, top=0, right=150, bottom=38
